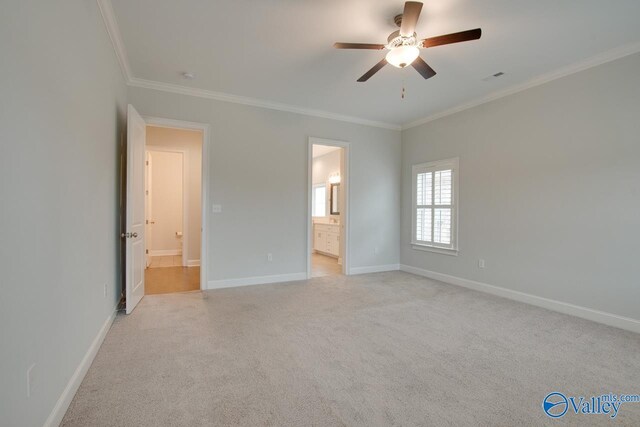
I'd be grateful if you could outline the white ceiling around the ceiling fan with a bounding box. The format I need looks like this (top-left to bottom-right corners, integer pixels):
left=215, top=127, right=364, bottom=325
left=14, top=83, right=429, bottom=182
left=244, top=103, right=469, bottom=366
left=107, top=0, right=640, bottom=125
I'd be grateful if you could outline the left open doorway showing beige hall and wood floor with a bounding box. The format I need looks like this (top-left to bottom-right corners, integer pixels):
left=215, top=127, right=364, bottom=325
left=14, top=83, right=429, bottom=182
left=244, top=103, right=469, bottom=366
left=145, top=125, right=203, bottom=295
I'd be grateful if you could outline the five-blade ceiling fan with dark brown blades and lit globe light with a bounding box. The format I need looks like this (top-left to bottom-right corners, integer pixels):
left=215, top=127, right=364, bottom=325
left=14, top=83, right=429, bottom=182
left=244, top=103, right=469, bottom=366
left=333, top=1, right=482, bottom=82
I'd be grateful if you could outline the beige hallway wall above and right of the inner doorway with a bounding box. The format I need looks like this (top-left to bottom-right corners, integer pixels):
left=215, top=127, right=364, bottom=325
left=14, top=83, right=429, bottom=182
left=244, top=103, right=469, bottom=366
left=147, top=126, right=202, bottom=262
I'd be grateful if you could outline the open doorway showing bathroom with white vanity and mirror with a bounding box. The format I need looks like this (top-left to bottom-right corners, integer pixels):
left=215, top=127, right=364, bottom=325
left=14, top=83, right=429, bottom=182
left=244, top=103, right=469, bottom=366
left=307, top=138, right=348, bottom=277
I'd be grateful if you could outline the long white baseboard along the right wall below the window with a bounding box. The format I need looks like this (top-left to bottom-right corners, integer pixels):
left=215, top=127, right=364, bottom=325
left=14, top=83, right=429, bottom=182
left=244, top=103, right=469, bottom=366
left=400, top=264, right=640, bottom=333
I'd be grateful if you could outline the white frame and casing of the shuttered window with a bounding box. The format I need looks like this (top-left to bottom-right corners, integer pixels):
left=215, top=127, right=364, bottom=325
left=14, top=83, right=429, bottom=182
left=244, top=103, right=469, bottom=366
left=410, top=157, right=460, bottom=256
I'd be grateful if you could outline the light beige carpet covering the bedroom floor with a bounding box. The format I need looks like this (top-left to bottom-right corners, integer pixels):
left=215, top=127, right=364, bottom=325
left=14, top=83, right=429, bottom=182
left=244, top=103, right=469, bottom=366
left=63, top=272, right=640, bottom=426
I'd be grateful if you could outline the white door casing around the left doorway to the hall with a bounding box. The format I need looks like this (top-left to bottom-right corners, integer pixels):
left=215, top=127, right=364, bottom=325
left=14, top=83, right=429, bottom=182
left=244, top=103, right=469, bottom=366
left=142, top=116, right=211, bottom=290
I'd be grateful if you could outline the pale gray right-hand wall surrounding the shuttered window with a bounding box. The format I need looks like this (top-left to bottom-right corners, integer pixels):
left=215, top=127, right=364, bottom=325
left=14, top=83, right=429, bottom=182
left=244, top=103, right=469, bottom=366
left=401, top=54, right=640, bottom=320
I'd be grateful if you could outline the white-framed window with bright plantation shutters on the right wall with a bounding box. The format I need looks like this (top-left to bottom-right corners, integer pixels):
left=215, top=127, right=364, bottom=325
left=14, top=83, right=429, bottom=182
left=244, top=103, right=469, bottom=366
left=411, top=158, right=458, bottom=254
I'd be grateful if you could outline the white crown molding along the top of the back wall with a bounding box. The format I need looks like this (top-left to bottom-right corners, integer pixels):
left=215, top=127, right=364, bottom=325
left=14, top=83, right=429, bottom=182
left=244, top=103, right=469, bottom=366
left=128, top=77, right=401, bottom=131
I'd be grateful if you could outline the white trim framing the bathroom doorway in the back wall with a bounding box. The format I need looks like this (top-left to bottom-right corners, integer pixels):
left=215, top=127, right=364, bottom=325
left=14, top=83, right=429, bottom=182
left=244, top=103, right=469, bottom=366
left=307, top=136, right=351, bottom=279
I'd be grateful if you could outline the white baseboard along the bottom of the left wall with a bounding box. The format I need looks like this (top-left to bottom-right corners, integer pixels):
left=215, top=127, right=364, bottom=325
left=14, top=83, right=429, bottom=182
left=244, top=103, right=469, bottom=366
left=44, top=310, right=117, bottom=427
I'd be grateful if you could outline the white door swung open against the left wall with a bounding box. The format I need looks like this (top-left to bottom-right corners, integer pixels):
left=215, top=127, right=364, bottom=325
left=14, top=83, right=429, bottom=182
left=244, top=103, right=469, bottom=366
left=123, top=105, right=146, bottom=314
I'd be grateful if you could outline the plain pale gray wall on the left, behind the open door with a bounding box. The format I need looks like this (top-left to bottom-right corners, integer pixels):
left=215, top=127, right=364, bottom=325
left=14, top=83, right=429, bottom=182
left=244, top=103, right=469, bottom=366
left=0, top=0, right=127, bottom=426
